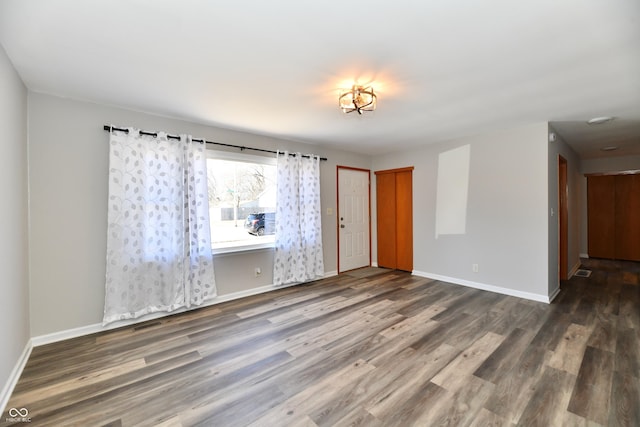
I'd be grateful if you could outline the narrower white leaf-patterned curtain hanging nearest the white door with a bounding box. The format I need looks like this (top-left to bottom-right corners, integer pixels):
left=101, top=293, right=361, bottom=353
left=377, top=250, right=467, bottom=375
left=273, top=151, right=324, bottom=285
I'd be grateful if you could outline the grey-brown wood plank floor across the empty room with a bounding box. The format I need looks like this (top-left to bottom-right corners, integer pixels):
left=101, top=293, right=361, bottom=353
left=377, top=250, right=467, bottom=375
left=0, top=260, right=640, bottom=427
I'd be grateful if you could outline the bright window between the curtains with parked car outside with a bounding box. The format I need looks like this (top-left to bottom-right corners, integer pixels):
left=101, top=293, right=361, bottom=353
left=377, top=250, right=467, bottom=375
left=207, top=151, right=276, bottom=252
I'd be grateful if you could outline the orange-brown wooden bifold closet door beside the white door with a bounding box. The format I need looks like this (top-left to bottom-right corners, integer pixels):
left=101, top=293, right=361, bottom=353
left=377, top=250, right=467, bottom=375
left=376, top=168, right=413, bottom=271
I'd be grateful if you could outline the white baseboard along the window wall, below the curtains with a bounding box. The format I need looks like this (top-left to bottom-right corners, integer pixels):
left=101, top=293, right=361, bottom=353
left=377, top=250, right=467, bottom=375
left=31, top=271, right=338, bottom=347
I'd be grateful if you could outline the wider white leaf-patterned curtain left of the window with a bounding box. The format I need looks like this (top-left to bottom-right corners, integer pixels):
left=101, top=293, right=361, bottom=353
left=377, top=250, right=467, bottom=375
left=103, top=128, right=216, bottom=324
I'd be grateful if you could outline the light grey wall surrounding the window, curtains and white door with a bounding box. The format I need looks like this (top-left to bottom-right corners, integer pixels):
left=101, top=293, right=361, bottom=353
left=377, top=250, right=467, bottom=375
left=29, top=92, right=371, bottom=337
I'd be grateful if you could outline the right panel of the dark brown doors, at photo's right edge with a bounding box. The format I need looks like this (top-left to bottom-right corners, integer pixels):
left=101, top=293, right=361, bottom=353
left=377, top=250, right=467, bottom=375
left=614, top=175, right=640, bottom=261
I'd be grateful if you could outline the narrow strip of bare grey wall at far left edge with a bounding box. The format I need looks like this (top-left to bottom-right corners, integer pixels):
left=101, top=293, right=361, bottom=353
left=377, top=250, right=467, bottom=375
left=0, top=45, right=30, bottom=408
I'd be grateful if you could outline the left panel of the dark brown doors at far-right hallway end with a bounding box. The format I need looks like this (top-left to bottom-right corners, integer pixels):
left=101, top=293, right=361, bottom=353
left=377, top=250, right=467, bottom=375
left=587, top=175, right=616, bottom=259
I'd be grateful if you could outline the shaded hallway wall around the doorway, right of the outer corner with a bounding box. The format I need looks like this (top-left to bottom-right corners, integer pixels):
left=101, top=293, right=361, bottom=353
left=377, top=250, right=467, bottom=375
left=549, top=127, right=583, bottom=295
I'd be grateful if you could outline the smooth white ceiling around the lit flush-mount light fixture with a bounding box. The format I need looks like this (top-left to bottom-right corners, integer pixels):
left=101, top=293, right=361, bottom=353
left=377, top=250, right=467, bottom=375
left=0, top=0, right=640, bottom=157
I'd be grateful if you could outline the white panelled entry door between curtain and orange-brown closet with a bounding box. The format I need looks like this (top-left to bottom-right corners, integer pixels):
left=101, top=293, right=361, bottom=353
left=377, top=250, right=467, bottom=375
left=338, top=166, right=371, bottom=272
